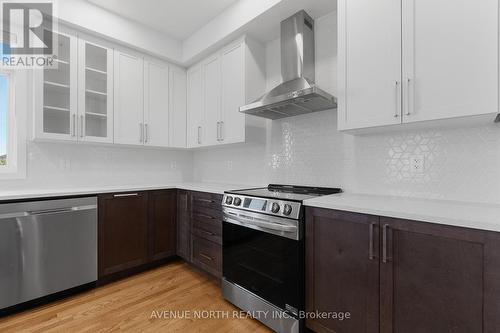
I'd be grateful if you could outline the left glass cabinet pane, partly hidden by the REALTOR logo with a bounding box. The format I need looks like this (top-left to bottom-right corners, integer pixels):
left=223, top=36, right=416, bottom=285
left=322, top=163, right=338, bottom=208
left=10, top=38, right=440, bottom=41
left=43, top=35, right=73, bottom=134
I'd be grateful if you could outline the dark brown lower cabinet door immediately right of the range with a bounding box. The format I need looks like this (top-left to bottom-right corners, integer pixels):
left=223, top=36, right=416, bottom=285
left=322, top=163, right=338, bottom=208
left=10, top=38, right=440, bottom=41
left=306, top=208, right=378, bottom=333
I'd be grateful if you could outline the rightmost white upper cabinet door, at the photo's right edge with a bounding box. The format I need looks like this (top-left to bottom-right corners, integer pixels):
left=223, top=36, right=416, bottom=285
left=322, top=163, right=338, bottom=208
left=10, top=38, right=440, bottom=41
left=402, top=0, right=499, bottom=122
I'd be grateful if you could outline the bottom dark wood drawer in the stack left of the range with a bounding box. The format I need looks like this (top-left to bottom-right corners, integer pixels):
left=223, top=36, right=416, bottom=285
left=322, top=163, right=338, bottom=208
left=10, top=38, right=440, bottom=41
left=192, top=235, right=222, bottom=276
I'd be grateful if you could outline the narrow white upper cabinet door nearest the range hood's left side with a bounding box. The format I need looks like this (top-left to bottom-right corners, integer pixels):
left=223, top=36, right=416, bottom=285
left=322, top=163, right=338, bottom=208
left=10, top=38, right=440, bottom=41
left=223, top=43, right=245, bottom=143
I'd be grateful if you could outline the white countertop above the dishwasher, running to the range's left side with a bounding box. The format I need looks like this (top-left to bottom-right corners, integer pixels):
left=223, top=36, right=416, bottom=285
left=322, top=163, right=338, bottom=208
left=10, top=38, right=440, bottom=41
left=0, top=183, right=254, bottom=201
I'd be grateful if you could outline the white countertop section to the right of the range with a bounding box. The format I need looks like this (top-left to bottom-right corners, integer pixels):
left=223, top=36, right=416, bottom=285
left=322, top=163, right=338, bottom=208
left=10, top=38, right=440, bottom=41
left=304, top=193, right=500, bottom=232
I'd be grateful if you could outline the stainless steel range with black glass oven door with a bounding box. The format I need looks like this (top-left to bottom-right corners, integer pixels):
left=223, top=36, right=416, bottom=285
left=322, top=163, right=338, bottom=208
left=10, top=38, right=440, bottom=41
left=222, top=185, right=341, bottom=332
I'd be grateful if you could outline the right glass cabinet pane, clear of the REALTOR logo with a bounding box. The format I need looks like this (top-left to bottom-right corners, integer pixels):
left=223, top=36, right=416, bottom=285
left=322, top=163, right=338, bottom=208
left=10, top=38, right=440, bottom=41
left=85, top=44, right=108, bottom=138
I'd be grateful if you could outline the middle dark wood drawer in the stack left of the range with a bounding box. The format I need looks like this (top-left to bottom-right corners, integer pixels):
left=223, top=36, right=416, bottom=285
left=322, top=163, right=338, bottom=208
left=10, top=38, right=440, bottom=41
left=192, top=209, right=222, bottom=244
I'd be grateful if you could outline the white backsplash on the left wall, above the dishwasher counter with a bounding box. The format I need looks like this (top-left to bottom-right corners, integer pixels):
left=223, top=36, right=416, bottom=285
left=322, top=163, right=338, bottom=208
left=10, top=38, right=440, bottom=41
left=0, top=142, right=192, bottom=190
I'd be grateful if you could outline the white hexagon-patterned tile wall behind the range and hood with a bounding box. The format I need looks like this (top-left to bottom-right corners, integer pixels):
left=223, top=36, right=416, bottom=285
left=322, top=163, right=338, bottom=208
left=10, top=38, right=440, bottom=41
left=194, top=13, right=500, bottom=203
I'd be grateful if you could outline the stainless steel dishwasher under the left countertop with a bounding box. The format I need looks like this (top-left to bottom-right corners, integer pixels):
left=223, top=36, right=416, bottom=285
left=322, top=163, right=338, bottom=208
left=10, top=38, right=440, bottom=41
left=0, top=197, right=97, bottom=309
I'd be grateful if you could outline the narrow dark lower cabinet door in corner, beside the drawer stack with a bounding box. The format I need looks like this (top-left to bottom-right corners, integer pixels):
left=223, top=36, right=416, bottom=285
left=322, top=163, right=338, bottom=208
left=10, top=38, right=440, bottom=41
left=177, top=190, right=191, bottom=261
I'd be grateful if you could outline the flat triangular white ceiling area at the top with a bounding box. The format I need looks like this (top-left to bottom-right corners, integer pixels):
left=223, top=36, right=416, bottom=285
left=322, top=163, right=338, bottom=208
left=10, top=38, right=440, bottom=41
left=87, top=0, right=237, bottom=40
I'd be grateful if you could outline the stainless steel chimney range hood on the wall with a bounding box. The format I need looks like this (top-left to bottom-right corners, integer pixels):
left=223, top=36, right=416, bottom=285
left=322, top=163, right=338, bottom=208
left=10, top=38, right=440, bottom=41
left=240, top=10, right=337, bottom=119
